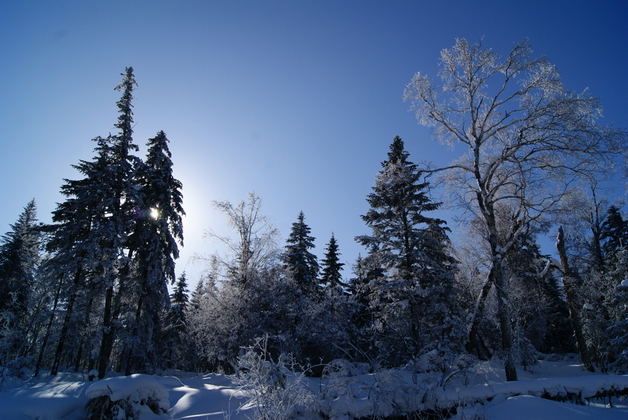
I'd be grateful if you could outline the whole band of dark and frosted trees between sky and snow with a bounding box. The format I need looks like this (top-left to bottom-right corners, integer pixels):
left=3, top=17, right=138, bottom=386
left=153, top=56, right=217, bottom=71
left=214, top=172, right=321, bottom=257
left=0, top=39, right=628, bottom=416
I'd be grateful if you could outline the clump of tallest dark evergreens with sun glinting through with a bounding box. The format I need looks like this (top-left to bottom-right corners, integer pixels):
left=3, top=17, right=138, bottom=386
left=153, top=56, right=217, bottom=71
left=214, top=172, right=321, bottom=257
left=26, top=67, right=185, bottom=377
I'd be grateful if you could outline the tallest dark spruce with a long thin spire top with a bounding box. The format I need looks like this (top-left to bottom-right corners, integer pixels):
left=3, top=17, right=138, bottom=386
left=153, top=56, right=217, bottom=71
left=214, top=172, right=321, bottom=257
left=48, top=67, right=142, bottom=377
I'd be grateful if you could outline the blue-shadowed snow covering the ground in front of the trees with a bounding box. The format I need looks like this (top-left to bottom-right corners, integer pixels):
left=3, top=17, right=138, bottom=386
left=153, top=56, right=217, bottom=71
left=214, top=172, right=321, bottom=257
left=0, top=359, right=628, bottom=420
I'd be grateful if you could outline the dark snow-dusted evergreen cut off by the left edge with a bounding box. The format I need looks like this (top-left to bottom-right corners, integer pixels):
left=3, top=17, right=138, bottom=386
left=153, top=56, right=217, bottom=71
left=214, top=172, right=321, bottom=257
left=0, top=199, right=41, bottom=364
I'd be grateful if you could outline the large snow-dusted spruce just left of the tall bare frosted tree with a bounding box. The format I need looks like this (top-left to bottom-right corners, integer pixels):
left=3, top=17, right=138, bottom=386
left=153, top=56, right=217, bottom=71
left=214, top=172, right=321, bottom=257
left=356, top=136, right=462, bottom=364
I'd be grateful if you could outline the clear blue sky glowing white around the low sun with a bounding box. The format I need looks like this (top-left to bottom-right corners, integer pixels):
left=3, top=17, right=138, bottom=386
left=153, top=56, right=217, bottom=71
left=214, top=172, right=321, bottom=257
left=0, top=0, right=628, bottom=283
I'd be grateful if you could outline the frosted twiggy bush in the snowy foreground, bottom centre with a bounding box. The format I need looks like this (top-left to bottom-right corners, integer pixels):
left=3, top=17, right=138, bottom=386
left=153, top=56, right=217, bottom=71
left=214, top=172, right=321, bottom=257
left=235, top=338, right=318, bottom=420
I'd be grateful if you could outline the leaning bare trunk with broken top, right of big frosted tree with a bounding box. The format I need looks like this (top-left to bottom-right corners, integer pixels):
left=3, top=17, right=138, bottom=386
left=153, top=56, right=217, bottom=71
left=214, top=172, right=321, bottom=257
left=556, top=226, right=595, bottom=372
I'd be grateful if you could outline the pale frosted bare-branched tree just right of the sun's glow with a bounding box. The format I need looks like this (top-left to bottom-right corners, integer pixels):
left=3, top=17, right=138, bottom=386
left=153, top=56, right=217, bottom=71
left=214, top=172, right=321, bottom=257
left=190, top=193, right=294, bottom=371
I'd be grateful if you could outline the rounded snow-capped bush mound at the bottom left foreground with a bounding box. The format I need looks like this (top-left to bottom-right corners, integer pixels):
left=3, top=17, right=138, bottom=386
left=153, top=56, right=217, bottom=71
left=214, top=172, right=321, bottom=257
left=85, top=374, right=170, bottom=420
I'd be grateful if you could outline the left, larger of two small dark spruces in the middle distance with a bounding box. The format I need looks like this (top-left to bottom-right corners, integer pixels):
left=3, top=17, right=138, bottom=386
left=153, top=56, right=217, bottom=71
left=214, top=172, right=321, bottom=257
left=283, top=212, right=319, bottom=294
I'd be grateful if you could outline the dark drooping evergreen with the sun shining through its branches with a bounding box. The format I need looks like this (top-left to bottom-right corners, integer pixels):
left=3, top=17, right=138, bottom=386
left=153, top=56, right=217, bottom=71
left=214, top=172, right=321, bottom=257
left=124, top=131, right=185, bottom=373
